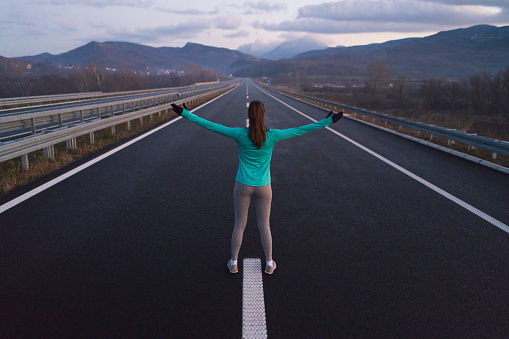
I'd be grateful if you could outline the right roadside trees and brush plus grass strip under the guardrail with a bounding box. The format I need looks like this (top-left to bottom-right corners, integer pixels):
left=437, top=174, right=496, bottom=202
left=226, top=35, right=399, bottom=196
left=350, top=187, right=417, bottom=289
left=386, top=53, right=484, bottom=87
left=260, top=62, right=509, bottom=167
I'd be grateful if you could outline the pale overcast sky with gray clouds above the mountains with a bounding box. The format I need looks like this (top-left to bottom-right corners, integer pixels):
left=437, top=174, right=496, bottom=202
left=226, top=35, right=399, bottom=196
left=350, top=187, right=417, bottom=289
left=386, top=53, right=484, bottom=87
left=0, top=0, right=509, bottom=57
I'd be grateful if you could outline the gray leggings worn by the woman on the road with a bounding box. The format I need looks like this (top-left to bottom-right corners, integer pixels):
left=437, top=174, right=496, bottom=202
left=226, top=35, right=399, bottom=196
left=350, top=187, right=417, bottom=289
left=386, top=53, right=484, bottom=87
left=232, top=181, right=272, bottom=260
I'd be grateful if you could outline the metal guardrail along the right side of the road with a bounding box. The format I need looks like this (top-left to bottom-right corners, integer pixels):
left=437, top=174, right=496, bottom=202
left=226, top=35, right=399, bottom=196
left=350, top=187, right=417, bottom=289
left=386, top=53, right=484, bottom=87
left=267, top=87, right=509, bottom=159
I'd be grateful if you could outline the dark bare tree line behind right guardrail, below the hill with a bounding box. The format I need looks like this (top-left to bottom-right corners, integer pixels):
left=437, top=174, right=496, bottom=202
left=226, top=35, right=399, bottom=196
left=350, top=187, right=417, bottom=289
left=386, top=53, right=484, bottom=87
left=302, top=61, right=509, bottom=118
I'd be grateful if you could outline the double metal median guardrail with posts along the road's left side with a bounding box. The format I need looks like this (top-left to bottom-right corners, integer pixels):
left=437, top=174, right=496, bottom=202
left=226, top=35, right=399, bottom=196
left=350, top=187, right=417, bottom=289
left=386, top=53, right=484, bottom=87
left=0, top=82, right=238, bottom=171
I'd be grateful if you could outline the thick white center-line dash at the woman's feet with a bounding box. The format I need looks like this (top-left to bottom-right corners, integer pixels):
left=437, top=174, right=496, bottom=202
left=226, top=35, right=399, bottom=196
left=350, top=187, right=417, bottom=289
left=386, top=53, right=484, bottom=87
left=242, top=258, right=267, bottom=338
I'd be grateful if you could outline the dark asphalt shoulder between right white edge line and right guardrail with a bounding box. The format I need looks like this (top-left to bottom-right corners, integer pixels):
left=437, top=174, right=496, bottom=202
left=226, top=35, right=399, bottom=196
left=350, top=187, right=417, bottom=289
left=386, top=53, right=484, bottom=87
left=262, top=86, right=509, bottom=231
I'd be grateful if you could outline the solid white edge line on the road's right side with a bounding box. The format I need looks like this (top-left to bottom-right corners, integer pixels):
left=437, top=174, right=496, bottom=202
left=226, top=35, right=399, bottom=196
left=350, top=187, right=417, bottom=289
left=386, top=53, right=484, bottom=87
left=259, top=88, right=509, bottom=234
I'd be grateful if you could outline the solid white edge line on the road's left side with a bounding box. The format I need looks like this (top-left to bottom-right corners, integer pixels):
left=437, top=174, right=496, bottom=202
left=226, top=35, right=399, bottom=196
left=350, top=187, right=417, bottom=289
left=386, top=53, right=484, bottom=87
left=0, top=83, right=236, bottom=214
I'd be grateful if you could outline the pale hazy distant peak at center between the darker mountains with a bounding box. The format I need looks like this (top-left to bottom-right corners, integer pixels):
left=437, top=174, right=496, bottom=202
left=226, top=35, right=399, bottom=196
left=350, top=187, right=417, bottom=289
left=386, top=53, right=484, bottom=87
left=237, top=37, right=327, bottom=60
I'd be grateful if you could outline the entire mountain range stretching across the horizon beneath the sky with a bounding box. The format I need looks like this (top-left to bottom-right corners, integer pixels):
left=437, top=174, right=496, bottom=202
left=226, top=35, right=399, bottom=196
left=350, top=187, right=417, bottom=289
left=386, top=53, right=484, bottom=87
left=0, top=25, right=509, bottom=79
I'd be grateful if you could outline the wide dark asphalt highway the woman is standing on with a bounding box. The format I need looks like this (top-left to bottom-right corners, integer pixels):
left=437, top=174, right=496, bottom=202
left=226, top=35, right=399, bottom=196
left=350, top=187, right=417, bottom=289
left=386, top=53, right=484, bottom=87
left=0, top=80, right=509, bottom=338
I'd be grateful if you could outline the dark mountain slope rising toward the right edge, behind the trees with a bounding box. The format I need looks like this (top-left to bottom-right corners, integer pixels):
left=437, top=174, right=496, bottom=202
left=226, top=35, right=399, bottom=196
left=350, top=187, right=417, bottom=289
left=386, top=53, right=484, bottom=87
left=237, top=25, right=509, bottom=79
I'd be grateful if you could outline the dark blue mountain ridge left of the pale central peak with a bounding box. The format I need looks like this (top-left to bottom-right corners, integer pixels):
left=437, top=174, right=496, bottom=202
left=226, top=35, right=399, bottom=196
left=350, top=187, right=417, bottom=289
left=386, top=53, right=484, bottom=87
left=19, top=41, right=256, bottom=73
